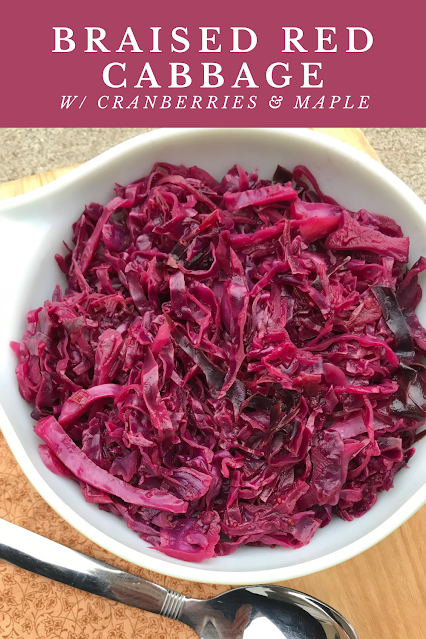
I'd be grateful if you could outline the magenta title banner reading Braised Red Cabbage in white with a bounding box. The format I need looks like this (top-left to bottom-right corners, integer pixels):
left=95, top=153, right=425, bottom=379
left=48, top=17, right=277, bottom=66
left=0, top=0, right=426, bottom=127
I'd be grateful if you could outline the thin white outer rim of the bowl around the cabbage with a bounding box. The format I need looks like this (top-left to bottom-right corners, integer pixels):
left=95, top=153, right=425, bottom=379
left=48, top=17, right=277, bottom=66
left=0, top=128, right=426, bottom=585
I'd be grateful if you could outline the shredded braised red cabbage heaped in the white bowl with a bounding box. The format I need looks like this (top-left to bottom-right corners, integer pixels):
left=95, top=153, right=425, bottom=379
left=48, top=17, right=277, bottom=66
left=12, top=163, right=426, bottom=561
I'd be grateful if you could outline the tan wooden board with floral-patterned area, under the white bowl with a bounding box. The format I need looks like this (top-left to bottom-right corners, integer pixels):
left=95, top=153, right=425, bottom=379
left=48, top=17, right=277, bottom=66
left=0, top=129, right=426, bottom=639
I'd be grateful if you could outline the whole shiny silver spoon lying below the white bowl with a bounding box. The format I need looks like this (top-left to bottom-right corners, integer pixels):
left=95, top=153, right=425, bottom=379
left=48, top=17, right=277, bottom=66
left=0, top=519, right=358, bottom=639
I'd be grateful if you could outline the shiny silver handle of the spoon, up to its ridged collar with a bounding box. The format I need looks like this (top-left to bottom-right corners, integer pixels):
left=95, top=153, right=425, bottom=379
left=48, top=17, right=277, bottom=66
left=0, top=519, right=186, bottom=619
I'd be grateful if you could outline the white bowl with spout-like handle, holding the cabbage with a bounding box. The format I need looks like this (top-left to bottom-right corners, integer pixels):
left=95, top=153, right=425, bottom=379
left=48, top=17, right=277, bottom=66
left=0, top=129, right=426, bottom=584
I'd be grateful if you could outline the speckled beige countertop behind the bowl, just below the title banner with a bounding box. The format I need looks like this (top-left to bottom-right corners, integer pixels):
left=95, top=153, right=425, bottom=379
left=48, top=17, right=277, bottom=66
left=0, top=128, right=426, bottom=201
